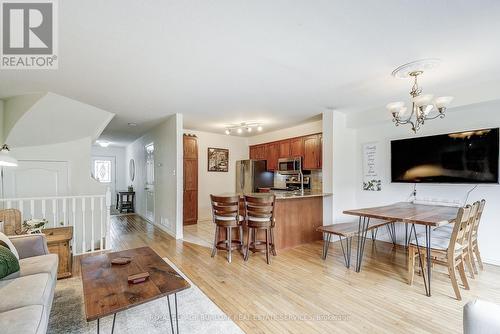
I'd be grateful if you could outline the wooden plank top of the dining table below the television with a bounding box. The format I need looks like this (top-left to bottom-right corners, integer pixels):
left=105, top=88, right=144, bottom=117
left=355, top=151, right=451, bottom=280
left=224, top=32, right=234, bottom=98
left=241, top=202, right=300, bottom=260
left=344, top=202, right=458, bottom=226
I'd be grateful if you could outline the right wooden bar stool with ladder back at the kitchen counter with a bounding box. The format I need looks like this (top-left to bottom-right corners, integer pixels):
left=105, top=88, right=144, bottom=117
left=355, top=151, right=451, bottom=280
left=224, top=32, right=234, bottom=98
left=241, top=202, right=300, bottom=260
left=245, top=195, right=276, bottom=264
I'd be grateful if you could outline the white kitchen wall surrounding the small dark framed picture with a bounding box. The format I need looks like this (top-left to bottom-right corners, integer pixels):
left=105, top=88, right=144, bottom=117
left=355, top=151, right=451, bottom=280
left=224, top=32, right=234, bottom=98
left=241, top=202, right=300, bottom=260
left=184, top=130, right=248, bottom=221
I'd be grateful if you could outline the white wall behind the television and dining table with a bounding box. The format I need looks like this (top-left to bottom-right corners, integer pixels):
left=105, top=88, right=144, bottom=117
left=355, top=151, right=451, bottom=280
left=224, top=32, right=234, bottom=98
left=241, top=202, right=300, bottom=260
left=340, top=101, right=500, bottom=264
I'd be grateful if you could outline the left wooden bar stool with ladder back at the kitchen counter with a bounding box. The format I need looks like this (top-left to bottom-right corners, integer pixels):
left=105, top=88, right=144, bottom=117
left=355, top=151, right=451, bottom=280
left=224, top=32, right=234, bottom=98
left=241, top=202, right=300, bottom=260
left=210, top=195, right=243, bottom=263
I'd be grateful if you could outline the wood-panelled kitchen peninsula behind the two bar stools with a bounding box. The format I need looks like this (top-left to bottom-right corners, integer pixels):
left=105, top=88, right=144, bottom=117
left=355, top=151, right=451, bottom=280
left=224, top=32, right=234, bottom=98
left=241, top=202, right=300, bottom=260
left=217, top=191, right=331, bottom=250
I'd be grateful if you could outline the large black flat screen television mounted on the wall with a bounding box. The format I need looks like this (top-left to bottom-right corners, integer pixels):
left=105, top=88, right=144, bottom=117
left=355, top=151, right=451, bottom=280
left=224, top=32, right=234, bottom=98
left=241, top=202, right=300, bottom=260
left=391, top=128, right=499, bottom=184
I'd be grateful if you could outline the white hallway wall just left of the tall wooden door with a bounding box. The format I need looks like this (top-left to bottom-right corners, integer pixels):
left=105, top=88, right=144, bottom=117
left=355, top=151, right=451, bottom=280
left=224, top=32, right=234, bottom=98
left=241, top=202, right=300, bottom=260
left=125, top=114, right=183, bottom=239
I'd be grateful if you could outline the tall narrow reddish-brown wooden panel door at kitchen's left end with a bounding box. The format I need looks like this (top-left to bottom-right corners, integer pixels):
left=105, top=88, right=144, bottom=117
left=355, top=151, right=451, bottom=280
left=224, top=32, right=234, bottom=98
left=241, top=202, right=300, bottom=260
left=183, top=135, right=198, bottom=225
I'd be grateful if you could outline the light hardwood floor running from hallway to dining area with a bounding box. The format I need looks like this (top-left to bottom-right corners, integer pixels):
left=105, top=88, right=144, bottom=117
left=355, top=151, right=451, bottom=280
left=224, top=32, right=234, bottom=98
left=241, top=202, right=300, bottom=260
left=74, top=215, right=500, bottom=334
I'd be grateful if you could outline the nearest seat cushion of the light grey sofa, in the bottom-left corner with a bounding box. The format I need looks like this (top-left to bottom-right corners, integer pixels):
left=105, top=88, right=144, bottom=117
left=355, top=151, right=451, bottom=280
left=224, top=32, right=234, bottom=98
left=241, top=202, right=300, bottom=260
left=0, top=305, right=47, bottom=334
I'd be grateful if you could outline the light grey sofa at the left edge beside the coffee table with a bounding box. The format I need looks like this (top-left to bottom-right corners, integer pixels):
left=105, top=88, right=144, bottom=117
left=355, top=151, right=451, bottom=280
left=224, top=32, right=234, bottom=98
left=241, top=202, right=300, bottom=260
left=0, top=234, right=58, bottom=334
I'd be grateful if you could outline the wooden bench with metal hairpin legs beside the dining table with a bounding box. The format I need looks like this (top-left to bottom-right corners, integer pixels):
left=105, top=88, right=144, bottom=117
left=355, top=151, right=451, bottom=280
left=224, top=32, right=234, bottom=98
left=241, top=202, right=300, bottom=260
left=316, top=220, right=393, bottom=268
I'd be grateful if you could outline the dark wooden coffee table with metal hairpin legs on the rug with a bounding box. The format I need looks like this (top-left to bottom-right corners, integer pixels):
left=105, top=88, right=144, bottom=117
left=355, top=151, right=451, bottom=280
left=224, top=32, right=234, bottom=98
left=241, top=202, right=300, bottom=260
left=81, top=247, right=190, bottom=333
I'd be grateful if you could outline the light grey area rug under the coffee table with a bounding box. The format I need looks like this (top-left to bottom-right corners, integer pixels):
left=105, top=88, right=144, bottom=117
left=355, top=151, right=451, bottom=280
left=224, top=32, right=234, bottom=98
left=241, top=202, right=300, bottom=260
left=47, top=259, right=243, bottom=334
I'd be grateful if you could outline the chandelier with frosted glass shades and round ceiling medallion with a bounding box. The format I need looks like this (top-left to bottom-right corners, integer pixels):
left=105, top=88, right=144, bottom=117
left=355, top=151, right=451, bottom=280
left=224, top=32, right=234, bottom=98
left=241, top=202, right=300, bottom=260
left=387, top=59, right=453, bottom=133
